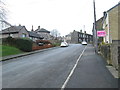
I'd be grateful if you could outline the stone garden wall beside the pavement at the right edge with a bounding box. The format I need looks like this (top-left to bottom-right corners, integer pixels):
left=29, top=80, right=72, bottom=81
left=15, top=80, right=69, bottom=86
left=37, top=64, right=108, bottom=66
left=100, top=40, right=120, bottom=70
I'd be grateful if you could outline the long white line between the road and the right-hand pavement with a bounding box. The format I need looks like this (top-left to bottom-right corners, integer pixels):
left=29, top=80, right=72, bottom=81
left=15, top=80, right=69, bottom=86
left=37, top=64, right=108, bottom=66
left=61, top=46, right=87, bottom=90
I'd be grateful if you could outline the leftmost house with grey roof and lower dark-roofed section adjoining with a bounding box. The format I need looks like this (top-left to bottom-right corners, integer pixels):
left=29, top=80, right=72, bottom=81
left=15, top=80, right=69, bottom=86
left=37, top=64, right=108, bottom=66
left=0, top=25, right=43, bottom=41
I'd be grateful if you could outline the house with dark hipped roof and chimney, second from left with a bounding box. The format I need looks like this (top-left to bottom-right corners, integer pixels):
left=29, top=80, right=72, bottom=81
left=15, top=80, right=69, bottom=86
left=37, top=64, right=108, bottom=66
left=35, top=26, right=51, bottom=40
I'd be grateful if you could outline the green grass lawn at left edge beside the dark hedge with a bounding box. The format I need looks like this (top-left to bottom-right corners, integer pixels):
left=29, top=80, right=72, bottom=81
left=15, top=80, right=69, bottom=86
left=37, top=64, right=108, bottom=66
left=0, top=45, right=23, bottom=57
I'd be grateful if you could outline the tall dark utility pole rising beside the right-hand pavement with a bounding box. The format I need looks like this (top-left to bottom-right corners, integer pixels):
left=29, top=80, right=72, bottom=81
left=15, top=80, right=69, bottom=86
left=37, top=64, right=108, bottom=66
left=93, top=0, right=98, bottom=53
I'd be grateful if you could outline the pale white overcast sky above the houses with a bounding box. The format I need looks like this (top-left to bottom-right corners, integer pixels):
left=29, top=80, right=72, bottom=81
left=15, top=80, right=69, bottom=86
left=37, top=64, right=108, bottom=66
left=5, top=0, right=120, bottom=36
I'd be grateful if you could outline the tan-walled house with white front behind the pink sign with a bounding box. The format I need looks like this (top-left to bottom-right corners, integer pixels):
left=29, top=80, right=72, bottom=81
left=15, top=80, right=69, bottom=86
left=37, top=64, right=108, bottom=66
left=103, top=3, right=120, bottom=43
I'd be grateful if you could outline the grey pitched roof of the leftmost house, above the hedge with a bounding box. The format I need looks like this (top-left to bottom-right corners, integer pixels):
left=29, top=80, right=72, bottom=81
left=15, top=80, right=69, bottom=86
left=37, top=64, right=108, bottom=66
left=0, top=26, right=26, bottom=34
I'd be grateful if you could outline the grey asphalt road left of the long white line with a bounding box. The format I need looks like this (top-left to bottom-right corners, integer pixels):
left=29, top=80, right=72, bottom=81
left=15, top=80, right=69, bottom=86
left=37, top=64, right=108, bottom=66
left=2, top=44, right=85, bottom=88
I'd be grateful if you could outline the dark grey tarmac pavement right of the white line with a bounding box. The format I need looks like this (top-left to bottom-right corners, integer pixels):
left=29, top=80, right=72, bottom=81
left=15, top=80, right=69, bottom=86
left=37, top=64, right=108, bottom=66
left=66, top=45, right=118, bottom=88
